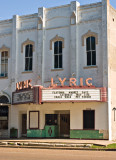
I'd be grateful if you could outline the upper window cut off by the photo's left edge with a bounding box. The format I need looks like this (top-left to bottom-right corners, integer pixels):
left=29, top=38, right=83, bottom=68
left=0, top=51, right=8, bottom=77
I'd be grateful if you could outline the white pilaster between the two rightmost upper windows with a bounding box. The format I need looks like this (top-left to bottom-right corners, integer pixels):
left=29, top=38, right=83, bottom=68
left=70, top=1, right=80, bottom=82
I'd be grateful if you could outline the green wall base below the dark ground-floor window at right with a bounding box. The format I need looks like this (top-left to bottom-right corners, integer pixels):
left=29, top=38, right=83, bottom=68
left=70, top=130, right=103, bottom=139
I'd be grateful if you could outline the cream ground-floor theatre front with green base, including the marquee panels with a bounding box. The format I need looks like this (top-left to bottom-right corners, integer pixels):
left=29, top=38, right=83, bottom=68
left=11, top=78, right=108, bottom=139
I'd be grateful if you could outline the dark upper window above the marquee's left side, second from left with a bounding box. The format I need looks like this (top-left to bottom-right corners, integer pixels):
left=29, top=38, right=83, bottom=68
left=25, top=44, right=33, bottom=71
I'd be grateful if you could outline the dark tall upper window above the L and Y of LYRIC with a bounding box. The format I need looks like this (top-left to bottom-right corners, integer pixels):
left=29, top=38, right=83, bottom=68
left=54, top=41, right=62, bottom=68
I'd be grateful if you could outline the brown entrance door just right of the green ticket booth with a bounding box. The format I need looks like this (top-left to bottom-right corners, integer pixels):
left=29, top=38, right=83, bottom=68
left=60, top=114, right=70, bottom=137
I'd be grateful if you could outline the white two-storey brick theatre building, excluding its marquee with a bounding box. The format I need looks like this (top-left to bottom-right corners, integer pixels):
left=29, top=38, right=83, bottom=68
left=0, top=0, right=116, bottom=139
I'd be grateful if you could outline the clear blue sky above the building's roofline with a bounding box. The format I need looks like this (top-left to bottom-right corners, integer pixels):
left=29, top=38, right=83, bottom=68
left=0, top=0, right=116, bottom=20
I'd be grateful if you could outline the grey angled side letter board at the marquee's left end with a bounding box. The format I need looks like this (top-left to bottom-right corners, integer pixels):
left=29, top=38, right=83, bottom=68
left=12, top=89, right=34, bottom=104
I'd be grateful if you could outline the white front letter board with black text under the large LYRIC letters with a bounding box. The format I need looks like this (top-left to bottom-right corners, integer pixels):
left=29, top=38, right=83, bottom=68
left=42, top=89, right=101, bottom=101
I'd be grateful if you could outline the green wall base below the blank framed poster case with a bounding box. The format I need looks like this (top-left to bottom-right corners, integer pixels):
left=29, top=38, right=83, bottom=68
left=27, top=129, right=45, bottom=138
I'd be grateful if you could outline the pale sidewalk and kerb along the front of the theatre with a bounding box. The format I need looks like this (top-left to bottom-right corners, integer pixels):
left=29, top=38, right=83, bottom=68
left=0, top=139, right=116, bottom=151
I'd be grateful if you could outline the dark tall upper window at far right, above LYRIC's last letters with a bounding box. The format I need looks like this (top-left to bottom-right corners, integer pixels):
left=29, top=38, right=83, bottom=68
left=86, top=36, right=96, bottom=66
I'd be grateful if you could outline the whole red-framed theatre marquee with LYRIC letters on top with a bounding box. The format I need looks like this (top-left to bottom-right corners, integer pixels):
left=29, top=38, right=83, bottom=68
left=12, top=78, right=107, bottom=104
